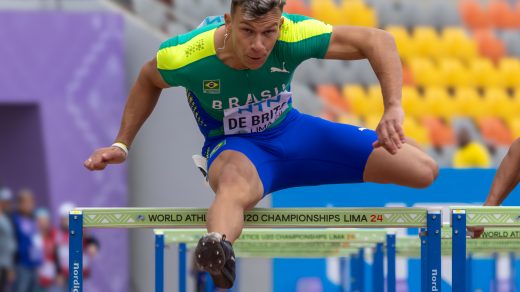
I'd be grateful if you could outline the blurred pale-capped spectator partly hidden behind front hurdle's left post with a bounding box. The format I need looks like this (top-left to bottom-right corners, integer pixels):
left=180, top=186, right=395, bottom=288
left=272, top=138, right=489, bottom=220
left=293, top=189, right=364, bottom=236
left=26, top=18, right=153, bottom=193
left=56, top=202, right=99, bottom=291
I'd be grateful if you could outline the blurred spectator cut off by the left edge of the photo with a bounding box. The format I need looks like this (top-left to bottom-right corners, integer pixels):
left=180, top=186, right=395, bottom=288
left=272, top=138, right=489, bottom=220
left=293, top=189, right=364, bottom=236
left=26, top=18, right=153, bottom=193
left=0, top=186, right=16, bottom=292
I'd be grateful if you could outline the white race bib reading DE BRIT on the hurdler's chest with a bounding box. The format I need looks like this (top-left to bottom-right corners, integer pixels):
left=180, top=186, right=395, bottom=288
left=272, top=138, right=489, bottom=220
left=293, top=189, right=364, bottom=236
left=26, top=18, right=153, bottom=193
left=224, top=92, right=292, bottom=135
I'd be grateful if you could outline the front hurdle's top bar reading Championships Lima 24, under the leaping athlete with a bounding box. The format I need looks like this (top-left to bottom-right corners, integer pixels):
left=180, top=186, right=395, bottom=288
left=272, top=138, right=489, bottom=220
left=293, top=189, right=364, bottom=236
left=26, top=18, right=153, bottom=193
left=80, top=208, right=426, bottom=228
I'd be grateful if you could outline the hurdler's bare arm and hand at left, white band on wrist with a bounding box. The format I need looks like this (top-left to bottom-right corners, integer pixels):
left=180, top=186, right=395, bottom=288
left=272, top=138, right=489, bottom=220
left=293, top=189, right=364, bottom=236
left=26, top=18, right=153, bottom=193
left=84, top=58, right=170, bottom=170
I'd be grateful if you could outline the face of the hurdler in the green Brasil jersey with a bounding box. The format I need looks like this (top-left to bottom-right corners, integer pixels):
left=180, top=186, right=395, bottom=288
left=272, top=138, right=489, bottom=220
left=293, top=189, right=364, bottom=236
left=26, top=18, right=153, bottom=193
left=226, top=8, right=283, bottom=69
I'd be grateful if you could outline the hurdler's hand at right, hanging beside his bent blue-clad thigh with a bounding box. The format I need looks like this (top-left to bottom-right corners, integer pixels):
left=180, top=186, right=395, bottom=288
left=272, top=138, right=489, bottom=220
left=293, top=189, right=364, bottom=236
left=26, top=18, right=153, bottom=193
left=372, top=106, right=406, bottom=154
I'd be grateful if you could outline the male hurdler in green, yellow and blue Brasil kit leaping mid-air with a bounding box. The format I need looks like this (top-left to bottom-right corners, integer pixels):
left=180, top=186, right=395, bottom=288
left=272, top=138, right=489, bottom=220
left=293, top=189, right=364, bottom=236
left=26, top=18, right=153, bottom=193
left=85, top=0, right=438, bottom=288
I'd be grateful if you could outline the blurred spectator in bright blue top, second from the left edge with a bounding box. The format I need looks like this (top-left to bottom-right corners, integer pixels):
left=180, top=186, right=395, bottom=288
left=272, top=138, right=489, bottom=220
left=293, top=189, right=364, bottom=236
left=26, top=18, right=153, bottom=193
left=13, top=189, right=43, bottom=292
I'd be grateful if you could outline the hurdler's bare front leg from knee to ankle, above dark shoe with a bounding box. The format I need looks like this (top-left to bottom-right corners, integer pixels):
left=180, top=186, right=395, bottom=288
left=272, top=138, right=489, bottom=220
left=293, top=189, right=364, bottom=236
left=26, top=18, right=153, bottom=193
left=207, top=150, right=263, bottom=242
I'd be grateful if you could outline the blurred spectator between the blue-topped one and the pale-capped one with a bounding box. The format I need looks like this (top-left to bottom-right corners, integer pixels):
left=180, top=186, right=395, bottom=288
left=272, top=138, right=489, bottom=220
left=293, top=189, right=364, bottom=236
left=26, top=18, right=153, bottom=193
left=36, top=208, right=58, bottom=292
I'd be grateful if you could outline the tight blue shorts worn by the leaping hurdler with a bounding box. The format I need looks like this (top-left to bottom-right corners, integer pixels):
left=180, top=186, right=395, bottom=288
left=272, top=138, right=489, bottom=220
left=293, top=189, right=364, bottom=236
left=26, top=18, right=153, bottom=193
left=202, top=109, right=377, bottom=195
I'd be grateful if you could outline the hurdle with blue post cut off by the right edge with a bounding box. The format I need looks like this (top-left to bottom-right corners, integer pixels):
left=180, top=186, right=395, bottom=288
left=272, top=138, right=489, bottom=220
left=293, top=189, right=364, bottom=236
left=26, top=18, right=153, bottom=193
left=450, top=207, right=520, bottom=291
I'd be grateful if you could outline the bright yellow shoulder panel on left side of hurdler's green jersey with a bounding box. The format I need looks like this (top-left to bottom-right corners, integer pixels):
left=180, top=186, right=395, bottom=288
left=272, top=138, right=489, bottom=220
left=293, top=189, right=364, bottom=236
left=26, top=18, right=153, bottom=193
left=157, top=29, right=216, bottom=70
